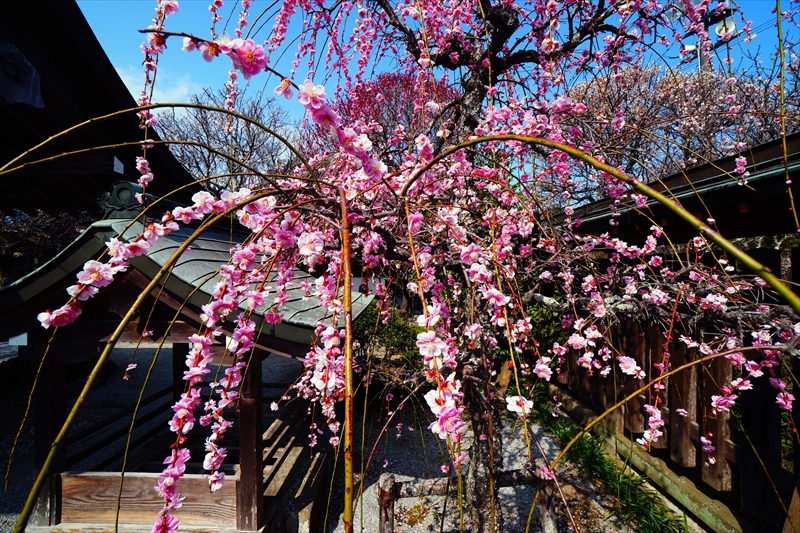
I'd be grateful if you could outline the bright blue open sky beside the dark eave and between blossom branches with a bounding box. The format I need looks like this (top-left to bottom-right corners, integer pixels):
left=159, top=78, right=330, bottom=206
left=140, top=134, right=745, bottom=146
left=78, top=0, right=789, bottom=105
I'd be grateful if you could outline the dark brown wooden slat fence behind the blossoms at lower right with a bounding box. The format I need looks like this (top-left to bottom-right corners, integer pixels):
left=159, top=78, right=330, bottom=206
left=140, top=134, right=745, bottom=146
left=557, top=320, right=800, bottom=531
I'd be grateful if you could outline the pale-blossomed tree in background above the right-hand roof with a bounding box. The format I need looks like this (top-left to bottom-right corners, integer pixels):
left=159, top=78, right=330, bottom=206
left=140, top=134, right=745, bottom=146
left=566, top=61, right=800, bottom=201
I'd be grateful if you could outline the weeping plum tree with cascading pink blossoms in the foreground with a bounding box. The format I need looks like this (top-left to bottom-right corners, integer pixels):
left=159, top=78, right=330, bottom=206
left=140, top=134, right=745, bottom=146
left=12, top=0, right=800, bottom=532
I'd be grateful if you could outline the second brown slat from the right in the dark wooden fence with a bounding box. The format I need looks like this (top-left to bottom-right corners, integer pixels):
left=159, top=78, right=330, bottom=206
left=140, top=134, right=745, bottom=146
left=668, top=341, right=697, bottom=467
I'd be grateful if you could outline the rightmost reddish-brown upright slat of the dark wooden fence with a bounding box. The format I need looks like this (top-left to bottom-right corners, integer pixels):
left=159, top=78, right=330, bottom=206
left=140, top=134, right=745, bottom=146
left=702, top=350, right=733, bottom=491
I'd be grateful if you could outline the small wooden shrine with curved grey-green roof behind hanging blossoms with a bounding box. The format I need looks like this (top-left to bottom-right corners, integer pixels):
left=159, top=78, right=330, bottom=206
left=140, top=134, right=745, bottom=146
left=0, top=213, right=369, bottom=531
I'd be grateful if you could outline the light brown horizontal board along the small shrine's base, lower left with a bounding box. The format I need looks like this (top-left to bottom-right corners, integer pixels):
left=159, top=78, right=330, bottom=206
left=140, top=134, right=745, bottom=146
left=61, top=472, right=239, bottom=528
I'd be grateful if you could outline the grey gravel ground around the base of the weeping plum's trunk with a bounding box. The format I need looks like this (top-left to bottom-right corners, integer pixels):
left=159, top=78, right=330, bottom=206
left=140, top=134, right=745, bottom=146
left=326, top=394, right=635, bottom=533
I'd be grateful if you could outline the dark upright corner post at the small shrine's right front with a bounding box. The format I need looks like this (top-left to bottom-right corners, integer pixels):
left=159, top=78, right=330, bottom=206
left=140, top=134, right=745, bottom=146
left=236, top=354, right=264, bottom=531
